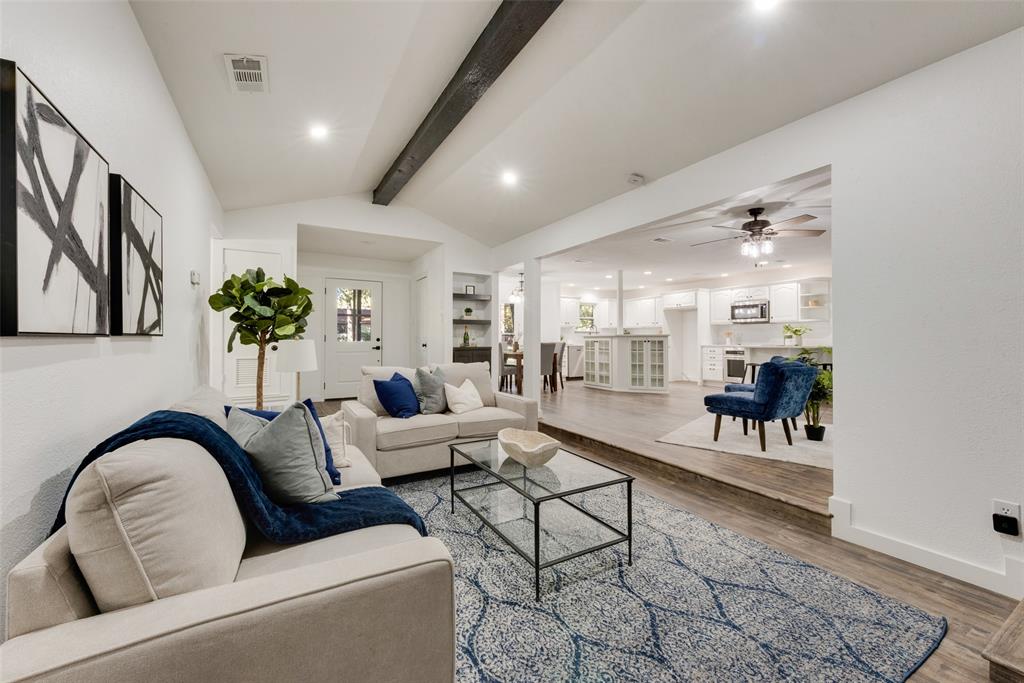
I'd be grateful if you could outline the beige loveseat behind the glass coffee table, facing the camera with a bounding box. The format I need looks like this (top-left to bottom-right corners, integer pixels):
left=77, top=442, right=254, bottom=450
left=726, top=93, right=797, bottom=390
left=341, top=362, right=538, bottom=478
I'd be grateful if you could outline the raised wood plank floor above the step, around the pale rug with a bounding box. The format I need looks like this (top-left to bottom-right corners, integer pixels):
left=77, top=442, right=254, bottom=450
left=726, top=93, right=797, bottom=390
left=541, top=381, right=833, bottom=516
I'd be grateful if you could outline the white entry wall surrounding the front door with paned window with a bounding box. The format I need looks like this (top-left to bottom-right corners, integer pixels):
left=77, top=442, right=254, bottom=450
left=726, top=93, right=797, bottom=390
left=298, top=252, right=413, bottom=400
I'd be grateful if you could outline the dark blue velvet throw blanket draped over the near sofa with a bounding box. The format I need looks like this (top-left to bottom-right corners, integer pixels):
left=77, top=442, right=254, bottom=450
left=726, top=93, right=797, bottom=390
left=50, top=411, right=427, bottom=544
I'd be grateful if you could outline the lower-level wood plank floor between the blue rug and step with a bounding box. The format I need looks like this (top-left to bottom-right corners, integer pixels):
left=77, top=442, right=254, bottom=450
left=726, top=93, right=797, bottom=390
left=566, top=436, right=1017, bottom=683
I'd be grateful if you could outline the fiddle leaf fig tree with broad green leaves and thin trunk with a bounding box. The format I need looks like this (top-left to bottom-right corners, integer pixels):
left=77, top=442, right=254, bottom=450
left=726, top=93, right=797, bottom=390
left=209, top=268, right=313, bottom=410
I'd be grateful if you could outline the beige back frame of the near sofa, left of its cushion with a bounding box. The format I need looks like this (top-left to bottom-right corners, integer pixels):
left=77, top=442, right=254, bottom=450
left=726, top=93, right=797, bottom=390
left=7, top=525, right=97, bottom=638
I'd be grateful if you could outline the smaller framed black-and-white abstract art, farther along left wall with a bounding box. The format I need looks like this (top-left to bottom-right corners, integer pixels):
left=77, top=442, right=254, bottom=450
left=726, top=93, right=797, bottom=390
left=110, top=174, right=164, bottom=337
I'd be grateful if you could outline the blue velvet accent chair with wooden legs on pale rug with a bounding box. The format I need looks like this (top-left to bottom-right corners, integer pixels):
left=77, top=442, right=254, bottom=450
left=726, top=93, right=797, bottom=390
left=705, top=356, right=818, bottom=451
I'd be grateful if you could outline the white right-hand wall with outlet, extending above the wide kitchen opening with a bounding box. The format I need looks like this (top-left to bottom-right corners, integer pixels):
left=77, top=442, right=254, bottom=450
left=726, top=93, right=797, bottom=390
left=494, top=30, right=1024, bottom=597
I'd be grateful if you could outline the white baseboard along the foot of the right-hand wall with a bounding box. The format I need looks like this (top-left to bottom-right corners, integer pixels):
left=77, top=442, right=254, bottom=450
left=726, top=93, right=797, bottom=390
left=828, top=496, right=1024, bottom=600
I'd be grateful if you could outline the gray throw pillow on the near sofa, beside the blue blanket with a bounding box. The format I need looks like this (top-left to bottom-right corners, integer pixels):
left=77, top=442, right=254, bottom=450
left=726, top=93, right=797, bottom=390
left=227, top=402, right=338, bottom=504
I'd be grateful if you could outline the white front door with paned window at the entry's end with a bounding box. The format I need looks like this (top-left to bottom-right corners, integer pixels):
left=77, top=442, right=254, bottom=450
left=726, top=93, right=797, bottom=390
left=324, top=278, right=383, bottom=398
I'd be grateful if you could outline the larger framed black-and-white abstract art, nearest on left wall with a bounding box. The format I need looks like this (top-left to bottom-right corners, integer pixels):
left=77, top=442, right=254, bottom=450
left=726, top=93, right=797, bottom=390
left=0, top=59, right=111, bottom=336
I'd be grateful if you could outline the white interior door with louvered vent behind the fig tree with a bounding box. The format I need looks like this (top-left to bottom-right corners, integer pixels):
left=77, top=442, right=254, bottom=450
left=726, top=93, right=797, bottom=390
left=223, top=248, right=285, bottom=404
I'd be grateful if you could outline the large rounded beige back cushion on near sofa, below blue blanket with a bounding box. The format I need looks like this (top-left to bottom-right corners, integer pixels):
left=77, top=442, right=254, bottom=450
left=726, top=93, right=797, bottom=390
left=68, top=438, right=246, bottom=611
